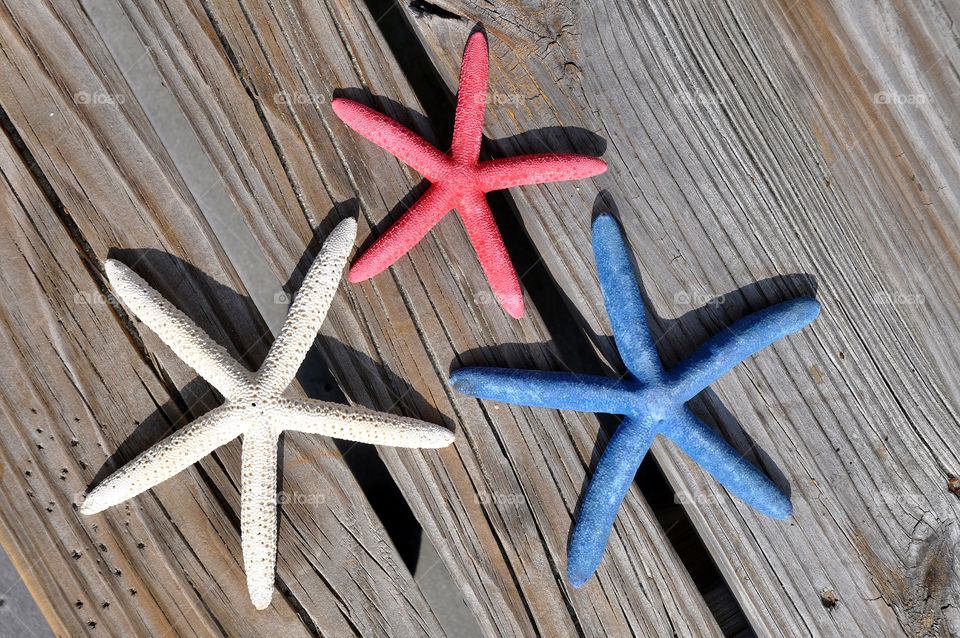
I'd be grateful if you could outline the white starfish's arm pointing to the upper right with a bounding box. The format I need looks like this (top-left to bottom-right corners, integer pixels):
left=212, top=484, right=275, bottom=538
left=256, top=218, right=357, bottom=397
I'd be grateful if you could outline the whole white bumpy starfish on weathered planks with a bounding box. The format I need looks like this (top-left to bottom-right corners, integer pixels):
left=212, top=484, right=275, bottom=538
left=80, top=219, right=453, bottom=609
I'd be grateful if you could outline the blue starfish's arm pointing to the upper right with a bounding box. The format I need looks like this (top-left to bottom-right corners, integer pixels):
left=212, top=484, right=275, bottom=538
left=667, top=297, right=820, bottom=402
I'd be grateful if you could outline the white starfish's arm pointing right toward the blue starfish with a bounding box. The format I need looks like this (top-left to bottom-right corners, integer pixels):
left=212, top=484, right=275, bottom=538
left=276, top=399, right=454, bottom=448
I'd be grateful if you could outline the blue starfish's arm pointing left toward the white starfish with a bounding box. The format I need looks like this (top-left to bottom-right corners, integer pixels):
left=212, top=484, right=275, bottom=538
left=450, top=368, right=631, bottom=414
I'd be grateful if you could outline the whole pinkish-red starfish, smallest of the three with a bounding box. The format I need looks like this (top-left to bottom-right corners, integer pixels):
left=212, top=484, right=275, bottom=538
left=332, top=32, right=607, bottom=319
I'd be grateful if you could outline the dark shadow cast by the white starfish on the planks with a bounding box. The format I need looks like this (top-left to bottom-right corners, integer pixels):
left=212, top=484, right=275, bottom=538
left=87, top=229, right=453, bottom=572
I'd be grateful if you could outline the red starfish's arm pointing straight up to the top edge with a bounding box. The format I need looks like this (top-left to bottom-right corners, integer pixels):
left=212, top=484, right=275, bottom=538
left=450, top=31, right=490, bottom=164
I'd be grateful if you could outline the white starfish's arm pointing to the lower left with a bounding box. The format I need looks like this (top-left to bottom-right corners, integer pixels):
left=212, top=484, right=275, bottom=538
left=80, top=405, right=243, bottom=514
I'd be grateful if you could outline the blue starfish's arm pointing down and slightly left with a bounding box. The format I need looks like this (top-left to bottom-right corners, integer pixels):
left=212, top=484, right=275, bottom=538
left=567, top=416, right=657, bottom=587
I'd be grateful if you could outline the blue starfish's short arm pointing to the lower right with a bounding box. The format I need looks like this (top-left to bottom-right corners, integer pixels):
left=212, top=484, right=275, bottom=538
left=661, top=407, right=793, bottom=520
